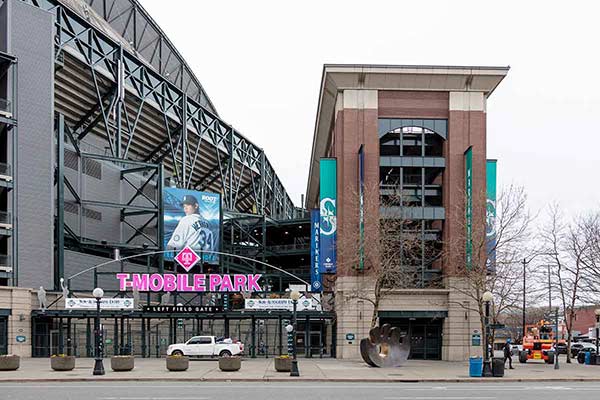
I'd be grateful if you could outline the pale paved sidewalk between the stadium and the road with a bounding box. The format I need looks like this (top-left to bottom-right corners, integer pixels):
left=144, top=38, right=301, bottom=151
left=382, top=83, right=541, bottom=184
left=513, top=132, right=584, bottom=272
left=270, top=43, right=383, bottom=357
left=0, top=358, right=600, bottom=382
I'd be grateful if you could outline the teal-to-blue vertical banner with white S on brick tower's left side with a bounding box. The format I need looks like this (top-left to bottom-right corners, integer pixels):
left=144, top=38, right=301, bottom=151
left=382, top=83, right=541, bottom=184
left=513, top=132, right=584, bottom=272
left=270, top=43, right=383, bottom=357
left=319, top=158, right=337, bottom=274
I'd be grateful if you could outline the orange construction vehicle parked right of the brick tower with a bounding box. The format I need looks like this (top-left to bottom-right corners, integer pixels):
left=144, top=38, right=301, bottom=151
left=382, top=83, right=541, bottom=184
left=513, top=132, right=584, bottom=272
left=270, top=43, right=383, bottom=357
left=519, top=320, right=565, bottom=364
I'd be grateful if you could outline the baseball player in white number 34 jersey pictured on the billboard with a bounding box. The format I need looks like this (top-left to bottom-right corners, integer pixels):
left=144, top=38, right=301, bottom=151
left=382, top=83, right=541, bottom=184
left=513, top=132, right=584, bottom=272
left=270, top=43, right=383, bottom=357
left=167, top=194, right=214, bottom=250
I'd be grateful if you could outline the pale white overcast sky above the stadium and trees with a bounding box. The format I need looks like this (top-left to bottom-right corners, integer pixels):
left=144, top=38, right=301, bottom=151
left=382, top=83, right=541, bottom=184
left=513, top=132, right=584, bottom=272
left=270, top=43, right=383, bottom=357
left=141, top=0, right=600, bottom=214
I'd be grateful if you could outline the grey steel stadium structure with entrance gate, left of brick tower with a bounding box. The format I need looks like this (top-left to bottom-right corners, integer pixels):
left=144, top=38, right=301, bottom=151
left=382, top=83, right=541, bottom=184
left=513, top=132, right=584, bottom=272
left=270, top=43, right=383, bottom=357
left=0, top=0, right=335, bottom=357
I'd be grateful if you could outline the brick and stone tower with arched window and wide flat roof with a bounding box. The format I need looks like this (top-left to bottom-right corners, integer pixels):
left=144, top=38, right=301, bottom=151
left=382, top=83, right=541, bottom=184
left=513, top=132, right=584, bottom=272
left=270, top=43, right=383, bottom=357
left=306, top=65, right=508, bottom=360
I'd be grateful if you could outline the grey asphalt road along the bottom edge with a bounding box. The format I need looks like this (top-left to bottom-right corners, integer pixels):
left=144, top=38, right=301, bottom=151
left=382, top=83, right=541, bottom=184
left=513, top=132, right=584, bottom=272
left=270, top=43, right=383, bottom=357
left=0, top=382, right=600, bottom=400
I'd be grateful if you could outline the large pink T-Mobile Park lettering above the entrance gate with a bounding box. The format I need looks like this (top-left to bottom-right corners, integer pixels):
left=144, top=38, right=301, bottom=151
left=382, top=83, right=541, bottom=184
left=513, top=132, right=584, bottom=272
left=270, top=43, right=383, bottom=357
left=116, top=274, right=262, bottom=292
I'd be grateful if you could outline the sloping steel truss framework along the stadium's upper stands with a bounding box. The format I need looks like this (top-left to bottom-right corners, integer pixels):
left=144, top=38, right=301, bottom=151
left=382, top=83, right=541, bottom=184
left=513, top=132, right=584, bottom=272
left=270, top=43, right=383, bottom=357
left=26, top=0, right=295, bottom=219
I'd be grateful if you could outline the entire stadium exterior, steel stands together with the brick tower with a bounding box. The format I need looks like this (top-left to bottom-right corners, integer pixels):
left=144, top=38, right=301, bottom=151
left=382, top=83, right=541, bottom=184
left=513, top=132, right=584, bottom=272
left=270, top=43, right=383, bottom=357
left=0, top=0, right=507, bottom=360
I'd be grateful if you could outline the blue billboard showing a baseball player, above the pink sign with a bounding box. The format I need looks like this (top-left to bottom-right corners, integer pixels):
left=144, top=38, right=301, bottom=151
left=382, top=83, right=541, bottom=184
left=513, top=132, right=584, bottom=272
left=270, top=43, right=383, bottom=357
left=163, top=188, right=221, bottom=264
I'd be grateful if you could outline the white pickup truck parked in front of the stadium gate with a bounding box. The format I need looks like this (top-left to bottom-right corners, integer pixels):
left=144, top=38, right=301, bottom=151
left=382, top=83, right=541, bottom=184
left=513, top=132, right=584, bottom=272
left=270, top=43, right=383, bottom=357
left=167, top=336, right=244, bottom=357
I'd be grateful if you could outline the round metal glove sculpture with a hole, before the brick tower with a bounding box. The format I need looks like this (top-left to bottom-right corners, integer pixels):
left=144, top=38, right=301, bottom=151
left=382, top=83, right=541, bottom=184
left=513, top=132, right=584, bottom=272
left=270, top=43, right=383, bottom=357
left=360, top=324, right=410, bottom=368
